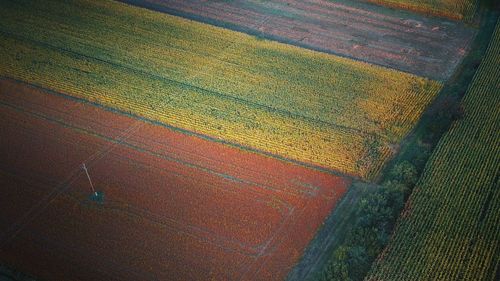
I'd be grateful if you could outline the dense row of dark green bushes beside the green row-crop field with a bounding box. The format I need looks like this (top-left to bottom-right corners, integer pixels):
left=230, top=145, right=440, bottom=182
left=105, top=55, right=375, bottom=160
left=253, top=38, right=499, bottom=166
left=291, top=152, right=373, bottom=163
left=320, top=161, right=418, bottom=281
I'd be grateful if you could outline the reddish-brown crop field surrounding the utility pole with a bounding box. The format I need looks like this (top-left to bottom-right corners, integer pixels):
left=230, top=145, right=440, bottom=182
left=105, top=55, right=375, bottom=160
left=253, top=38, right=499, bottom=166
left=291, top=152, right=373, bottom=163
left=0, top=77, right=350, bottom=280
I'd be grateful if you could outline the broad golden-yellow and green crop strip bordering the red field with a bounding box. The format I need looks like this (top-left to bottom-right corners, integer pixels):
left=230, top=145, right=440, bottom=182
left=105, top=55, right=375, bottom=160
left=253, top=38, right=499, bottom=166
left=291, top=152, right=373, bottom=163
left=0, top=0, right=442, bottom=179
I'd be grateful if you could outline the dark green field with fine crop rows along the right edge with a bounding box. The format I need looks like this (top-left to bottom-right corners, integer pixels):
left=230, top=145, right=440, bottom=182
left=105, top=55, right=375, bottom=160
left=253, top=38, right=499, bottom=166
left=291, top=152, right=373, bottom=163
left=367, top=22, right=500, bottom=280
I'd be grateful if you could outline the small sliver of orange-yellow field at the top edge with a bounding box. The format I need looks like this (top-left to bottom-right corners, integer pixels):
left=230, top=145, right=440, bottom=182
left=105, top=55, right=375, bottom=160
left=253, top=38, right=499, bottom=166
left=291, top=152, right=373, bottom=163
left=366, top=0, right=478, bottom=21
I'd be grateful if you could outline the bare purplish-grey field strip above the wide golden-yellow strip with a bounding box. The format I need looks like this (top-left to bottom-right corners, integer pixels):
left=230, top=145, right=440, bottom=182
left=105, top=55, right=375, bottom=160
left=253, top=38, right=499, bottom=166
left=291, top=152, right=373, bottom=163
left=122, top=0, right=474, bottom=80
